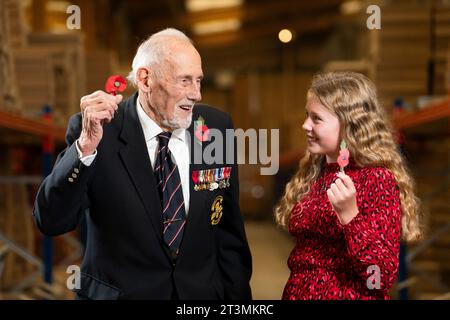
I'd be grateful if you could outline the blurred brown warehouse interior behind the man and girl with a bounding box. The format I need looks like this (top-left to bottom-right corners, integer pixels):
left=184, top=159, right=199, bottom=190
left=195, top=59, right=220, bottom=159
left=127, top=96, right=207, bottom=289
left=0, top=0, right=450, bottom=300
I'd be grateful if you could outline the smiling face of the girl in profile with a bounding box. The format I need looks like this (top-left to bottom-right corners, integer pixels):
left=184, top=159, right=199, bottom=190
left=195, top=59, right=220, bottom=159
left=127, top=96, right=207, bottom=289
left=302, top=93, right=340, bottom=163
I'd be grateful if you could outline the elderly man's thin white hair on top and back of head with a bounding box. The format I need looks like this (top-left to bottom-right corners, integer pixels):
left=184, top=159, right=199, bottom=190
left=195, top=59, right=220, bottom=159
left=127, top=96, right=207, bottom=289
left=127, top=28, right=192, bottom=87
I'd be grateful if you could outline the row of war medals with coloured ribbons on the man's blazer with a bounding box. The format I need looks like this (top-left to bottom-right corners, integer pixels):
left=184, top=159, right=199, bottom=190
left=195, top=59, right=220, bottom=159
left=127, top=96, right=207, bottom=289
left=192, top=167, right=231, bottom=191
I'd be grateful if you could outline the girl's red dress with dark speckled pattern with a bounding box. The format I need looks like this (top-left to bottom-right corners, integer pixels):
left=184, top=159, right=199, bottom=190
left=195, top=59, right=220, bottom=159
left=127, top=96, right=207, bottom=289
left=283, top=162, right=401, bottom=300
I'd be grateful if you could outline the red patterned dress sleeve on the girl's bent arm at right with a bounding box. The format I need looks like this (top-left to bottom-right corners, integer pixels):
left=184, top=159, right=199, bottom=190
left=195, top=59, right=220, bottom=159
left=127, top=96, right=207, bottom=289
left=343, top=168, right=401, bottom=290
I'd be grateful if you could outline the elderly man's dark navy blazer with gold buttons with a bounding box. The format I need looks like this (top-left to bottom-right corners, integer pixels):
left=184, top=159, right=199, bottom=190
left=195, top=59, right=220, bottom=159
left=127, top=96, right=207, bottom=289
left=33, top=93, right=252, bottom=299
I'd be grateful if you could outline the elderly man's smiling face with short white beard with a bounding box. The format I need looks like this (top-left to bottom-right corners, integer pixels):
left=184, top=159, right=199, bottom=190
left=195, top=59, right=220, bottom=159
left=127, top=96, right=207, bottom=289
left=149, top=44, right=203, bottom=130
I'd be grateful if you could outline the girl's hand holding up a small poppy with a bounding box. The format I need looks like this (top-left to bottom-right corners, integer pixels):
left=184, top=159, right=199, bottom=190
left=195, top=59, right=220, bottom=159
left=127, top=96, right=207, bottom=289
left=327, top=172, right=358, bottom=224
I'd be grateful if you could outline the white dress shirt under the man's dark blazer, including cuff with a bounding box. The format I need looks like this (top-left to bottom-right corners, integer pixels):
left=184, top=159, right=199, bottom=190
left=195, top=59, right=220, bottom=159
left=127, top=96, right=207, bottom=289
left=75, top=97, right=190, bottom=214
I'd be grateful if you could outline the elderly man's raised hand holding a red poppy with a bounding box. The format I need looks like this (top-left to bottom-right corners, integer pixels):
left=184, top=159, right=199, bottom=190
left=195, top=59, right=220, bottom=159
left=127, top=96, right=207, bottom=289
left=78, top=90, right=123, bottom=157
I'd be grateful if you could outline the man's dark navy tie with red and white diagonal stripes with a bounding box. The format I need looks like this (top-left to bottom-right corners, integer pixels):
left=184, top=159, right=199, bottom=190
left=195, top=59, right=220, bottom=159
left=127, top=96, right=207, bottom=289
left=154, top=132, right=186, bottom=258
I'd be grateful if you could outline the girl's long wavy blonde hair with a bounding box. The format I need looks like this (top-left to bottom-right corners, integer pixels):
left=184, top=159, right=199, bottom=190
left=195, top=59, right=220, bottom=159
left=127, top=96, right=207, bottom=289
left=275, top=72, right=422, bottom=241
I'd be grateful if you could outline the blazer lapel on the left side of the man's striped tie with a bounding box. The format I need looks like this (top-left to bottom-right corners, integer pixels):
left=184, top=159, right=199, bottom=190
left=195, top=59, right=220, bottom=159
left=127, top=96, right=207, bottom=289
left=119, top=93, right=162, bottom=236
